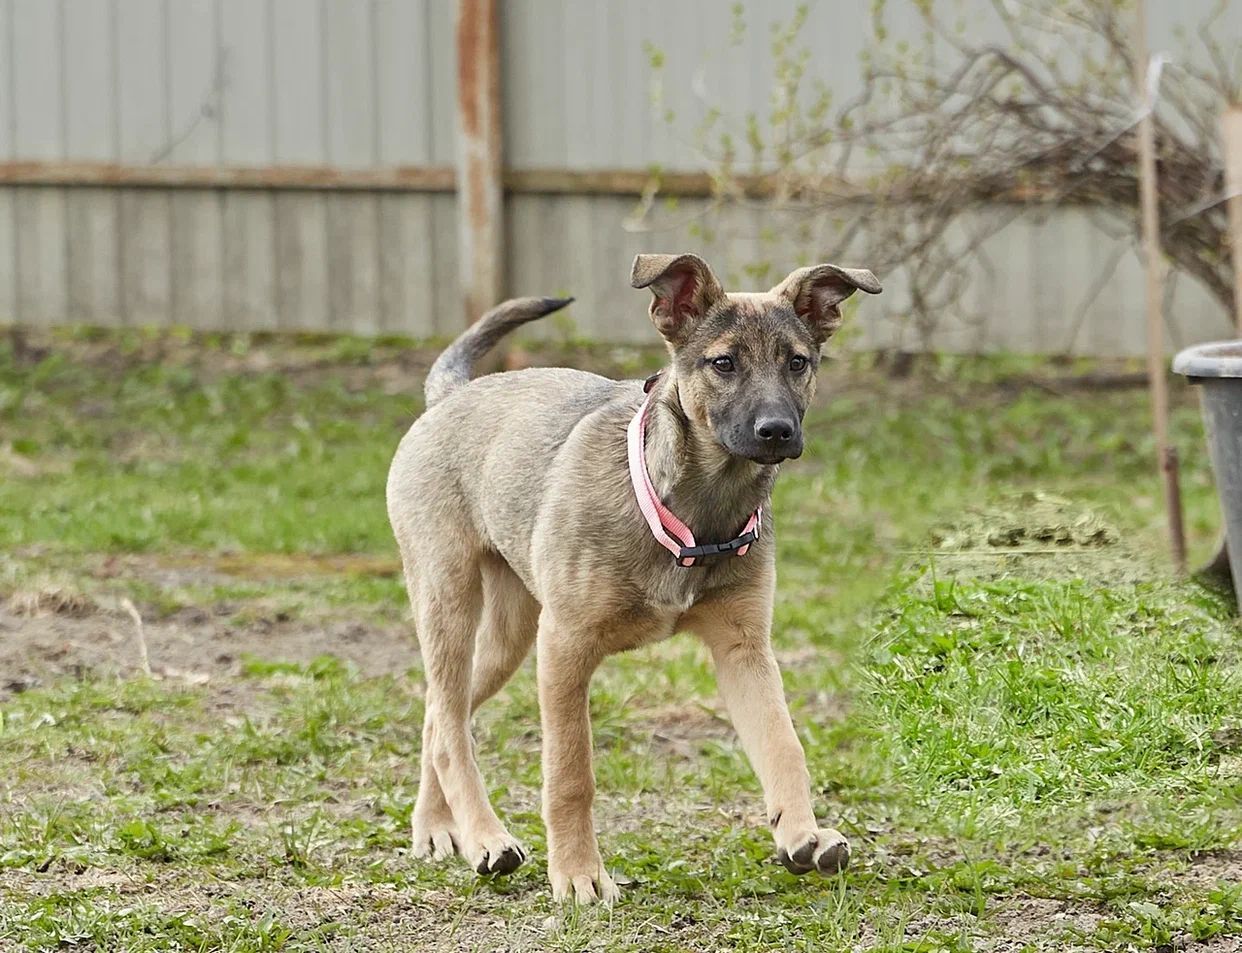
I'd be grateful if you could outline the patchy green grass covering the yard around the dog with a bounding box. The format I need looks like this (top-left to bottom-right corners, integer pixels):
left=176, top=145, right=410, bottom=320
left=0, top=334, right=1242, bottom=952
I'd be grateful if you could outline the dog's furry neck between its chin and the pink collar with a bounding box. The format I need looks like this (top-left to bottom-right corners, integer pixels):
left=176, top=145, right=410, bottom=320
left=646, top=373, right=780, bottom=543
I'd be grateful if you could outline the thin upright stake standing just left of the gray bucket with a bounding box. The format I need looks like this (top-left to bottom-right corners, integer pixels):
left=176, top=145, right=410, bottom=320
left=1134, top=0, right=1186, bottom=573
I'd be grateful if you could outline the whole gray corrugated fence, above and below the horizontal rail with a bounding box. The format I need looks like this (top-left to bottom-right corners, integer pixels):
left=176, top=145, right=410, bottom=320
left=0, top=0, right=1242, bottom=353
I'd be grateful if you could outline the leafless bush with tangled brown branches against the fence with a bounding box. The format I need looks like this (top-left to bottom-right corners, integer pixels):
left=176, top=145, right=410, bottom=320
left=635, top=0, right=1242, bottom=347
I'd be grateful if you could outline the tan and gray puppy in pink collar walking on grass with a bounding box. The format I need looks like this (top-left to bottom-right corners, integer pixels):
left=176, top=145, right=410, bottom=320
left=388, top=255, right=881, bottom=903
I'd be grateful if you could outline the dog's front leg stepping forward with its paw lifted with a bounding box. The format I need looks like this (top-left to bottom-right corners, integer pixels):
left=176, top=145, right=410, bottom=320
left=686, top=584, right=850, bottom=873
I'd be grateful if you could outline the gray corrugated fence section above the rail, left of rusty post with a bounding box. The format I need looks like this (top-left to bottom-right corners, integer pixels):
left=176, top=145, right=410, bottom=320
left=0, top=0, right=455, bottom=166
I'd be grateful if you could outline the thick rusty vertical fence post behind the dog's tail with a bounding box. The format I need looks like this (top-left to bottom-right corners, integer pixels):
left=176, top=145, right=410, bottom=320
left=457, top=0, right=504, bottom=324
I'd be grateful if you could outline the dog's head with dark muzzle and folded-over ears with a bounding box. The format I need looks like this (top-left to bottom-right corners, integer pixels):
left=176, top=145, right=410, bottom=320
left=630, top=255, right=881, bottom=463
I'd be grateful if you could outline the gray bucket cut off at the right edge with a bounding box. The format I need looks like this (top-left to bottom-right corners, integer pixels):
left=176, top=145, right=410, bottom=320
left=1172, top=340, right=1242, bottom=611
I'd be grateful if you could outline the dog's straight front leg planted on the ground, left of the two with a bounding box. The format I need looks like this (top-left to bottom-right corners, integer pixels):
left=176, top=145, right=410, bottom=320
left=535, top=610, right=619, bottom=903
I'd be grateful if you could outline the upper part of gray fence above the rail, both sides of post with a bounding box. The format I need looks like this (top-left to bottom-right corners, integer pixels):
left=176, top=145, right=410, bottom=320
left=0, top=0, right=1242, bottom=170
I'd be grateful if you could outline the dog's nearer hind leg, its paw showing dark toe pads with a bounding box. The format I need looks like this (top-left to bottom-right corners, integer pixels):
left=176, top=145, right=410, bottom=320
left=415, top=552, right=525, bottom=873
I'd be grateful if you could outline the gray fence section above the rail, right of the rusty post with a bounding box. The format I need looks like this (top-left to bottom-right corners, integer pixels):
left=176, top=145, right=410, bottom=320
left=494, top=0, right=871, bottom=169
